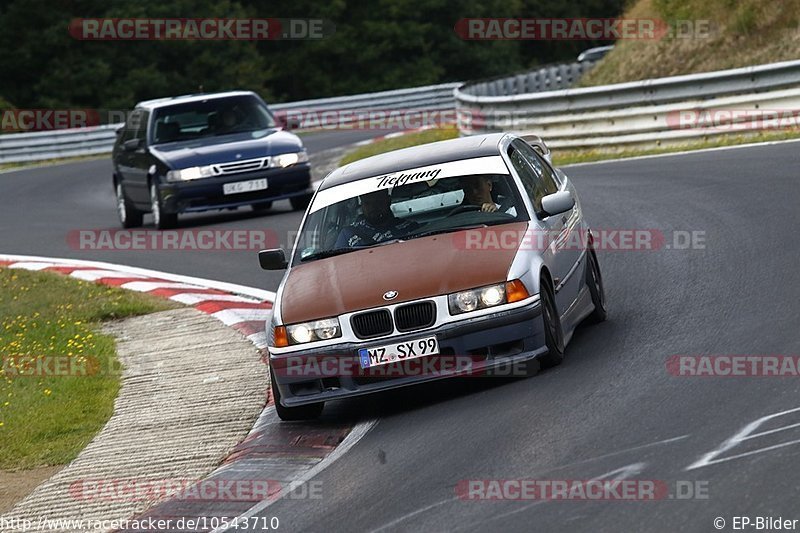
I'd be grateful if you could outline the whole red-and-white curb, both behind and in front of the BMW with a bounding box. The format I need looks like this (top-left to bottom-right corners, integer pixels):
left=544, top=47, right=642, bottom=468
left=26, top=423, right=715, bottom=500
left=0, top=254, right=377, bottom=532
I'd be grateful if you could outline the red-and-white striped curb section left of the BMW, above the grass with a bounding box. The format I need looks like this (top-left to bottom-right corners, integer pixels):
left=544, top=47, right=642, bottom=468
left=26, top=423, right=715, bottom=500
left=0, top=254, right=275, bottom=349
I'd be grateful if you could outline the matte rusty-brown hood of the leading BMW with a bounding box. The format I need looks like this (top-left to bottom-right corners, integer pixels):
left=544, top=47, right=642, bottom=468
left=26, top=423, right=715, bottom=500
left=281, top=222, right=527, bottom=324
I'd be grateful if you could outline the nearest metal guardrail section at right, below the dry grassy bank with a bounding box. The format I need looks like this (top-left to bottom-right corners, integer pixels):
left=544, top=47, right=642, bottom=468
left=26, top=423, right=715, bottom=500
left=454, top=61, right=800, bottom=148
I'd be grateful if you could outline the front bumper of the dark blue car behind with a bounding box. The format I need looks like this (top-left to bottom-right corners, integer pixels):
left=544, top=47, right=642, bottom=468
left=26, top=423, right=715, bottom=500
left=158, top=163, right=314, bottom=213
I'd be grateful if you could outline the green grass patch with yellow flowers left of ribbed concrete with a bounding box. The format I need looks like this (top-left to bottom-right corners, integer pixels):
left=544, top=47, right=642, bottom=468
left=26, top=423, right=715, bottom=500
left=0, top=268, right=175, bottom=470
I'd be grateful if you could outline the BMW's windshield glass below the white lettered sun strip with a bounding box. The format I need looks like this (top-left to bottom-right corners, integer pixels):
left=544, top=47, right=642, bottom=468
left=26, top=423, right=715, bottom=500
left=294, top=174, right=527, bottom=263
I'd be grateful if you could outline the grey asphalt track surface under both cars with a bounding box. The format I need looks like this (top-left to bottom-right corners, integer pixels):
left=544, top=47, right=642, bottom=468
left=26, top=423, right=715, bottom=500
left=0, top=134, right=800, bottom=531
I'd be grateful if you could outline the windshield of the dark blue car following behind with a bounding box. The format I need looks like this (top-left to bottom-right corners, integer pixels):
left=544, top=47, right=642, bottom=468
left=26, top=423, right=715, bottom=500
left=150, top=95, right=275, bottom=144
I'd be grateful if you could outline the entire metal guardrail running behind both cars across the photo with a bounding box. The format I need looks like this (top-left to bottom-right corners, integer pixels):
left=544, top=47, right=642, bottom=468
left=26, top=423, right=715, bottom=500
left=6, top=61, right=800, bottom=163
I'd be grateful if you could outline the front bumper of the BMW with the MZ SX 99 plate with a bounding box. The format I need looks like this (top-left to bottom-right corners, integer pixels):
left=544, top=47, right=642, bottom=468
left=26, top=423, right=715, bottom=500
left=270, top=302, right=547, bottom=407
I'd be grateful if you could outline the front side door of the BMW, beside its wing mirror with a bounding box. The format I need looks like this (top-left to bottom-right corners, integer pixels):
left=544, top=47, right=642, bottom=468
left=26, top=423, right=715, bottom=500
left=508, top=139, right=581, bottom=315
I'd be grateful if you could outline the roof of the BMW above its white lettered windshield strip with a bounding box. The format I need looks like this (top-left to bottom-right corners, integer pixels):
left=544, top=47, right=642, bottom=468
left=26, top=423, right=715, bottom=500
left=320, top=133, right=505, bottom=189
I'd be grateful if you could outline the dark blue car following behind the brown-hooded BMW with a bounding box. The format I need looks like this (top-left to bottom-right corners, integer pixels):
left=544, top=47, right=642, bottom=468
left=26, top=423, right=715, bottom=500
left=112, top=91, right=313, bottom=229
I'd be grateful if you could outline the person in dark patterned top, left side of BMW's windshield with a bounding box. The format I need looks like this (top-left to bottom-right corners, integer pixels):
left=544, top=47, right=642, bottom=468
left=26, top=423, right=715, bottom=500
left=334, top=189, right=419, bottom=248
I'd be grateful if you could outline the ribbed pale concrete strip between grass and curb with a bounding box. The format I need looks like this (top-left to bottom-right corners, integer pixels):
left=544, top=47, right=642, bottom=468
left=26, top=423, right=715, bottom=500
left=0, top=308, right=268, bottom=531
